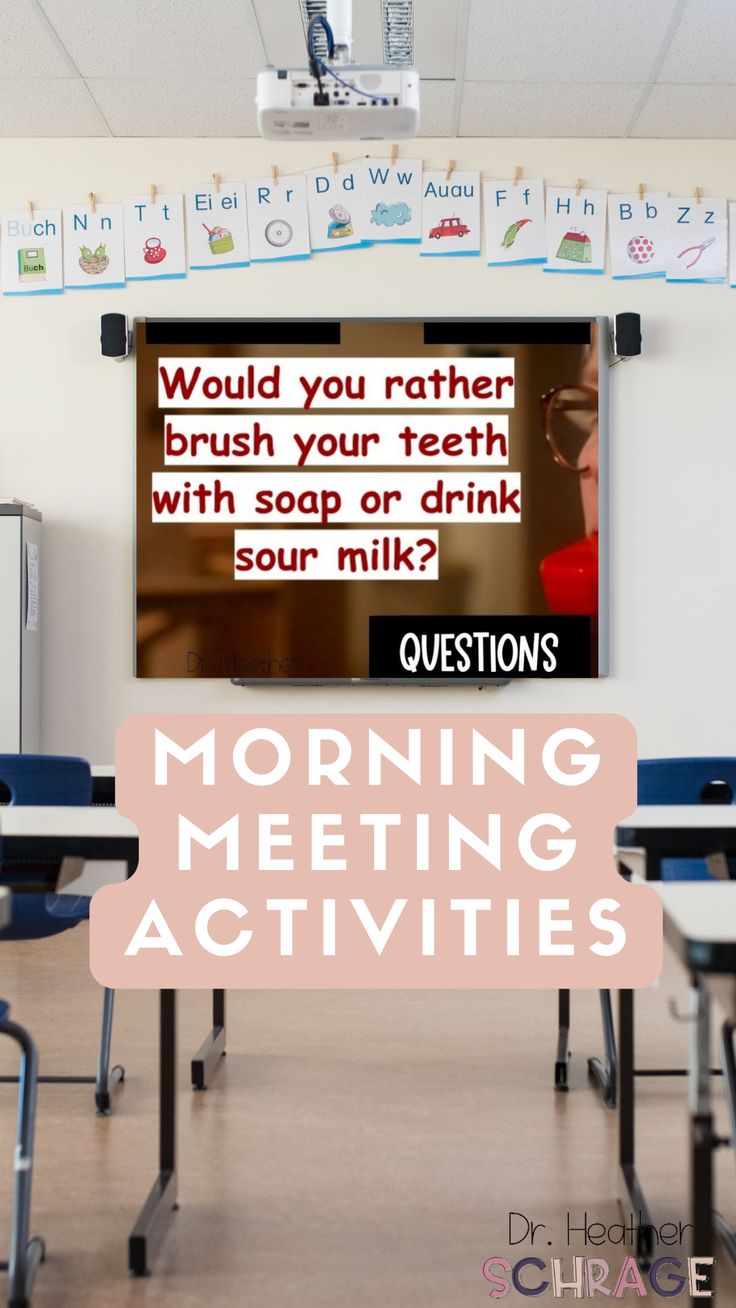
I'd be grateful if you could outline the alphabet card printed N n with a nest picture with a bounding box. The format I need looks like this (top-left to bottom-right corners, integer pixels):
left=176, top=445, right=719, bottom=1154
left=64, top=204, right=125, bottom=290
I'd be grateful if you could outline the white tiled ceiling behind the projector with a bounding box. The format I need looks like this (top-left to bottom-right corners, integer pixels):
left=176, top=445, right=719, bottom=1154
left=0, top=0, right=736, bottom=139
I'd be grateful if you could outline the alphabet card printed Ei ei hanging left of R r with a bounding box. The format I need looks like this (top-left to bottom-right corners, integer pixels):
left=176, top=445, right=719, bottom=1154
left=187, top=182, right=251, bottom=271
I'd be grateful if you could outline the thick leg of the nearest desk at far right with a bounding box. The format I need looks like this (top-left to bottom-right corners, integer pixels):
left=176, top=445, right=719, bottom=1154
left=689, top=978, right=715, bottom=1290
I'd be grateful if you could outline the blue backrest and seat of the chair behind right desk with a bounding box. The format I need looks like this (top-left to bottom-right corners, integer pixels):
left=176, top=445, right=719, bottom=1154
left=637, top=757, right=736, bottom=882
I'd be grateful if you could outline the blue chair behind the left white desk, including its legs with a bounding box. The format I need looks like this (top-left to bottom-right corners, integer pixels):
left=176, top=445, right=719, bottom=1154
left=0, top=753, right=124, bottom=1113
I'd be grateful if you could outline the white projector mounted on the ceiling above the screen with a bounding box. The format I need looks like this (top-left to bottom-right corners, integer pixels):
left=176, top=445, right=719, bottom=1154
left=256, top=0, right=420, bottom=141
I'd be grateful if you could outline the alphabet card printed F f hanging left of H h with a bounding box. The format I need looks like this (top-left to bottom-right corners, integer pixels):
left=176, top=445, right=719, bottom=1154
left=482, top=178, right=546, bottom=268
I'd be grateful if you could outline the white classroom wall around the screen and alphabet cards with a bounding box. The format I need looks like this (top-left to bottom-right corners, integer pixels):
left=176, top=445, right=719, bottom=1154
left=0, top=140, right=736, bottom=761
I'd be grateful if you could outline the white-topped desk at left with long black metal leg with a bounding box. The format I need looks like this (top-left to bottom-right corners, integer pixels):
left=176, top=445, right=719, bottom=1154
left=0, top=804, right=176, bottom=1277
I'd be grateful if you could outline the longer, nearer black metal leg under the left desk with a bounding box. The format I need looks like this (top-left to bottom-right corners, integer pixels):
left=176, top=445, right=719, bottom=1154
left=128, top=990, right=178, bottom=1277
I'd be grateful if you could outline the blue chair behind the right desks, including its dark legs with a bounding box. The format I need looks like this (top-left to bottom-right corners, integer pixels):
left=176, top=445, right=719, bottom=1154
left=554, top=757, right=736, bottom=1108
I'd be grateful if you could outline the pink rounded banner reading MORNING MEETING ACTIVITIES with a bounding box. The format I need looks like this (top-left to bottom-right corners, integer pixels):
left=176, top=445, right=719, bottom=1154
left=90, top=713, right=663, bottom=989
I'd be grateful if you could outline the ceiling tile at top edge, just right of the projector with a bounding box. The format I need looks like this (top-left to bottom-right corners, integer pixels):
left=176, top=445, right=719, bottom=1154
left=465, top=0, right=679, bottom=83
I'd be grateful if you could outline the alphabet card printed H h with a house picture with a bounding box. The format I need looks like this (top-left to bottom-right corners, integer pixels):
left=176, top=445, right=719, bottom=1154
left=544, top=186, right=605, bottom=273
